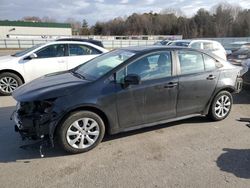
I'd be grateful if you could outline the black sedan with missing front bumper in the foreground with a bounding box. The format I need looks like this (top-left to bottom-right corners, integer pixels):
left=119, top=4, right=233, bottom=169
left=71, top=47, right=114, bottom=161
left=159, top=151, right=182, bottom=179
left=13, top=46, right=242, bottom=153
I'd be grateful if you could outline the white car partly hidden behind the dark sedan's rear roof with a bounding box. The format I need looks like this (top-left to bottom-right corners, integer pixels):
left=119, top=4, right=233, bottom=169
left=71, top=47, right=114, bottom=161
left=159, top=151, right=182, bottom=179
left=169, top=40, right=227, bottom=60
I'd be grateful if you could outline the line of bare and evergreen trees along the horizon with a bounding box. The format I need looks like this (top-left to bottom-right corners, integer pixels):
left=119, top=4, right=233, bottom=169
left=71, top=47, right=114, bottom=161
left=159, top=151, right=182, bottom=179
left=20, top=3, right=250, bottom=38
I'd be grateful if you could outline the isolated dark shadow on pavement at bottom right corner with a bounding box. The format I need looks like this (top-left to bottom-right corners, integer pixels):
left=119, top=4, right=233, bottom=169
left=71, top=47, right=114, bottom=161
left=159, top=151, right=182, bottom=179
left=217, top=148, right=250, bottom=179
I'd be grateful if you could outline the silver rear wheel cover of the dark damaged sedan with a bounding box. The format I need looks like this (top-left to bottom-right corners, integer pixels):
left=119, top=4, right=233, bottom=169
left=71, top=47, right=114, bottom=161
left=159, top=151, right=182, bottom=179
left=214, top=95, right=232, bottom=118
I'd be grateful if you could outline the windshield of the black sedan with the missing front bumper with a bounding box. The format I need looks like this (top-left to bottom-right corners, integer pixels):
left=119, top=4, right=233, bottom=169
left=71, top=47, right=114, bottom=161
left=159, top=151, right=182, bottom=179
left=74, top=49, right=135, bottom=80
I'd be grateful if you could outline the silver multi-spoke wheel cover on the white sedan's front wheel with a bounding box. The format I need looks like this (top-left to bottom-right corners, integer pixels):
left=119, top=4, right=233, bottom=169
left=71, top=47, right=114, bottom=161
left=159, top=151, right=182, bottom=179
left=0, top=76, right=18, bottom=93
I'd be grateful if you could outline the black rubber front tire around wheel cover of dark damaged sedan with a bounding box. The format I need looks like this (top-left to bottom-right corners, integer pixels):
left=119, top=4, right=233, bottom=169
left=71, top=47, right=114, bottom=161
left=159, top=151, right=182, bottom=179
left=57, top=111, right=105, bottom=154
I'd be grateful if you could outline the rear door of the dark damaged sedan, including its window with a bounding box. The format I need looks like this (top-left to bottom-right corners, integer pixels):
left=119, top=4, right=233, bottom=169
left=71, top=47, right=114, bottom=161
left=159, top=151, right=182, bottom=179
left=177, top=50, right=219, bottom=116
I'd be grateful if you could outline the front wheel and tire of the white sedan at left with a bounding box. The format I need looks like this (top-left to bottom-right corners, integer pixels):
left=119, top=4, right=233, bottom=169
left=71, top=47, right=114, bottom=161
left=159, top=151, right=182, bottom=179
left=0, top=72, right=23, bottom=96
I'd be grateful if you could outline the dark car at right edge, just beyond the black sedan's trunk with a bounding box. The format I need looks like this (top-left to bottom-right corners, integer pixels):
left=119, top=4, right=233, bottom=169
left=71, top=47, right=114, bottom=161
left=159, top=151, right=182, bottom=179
left=228, top=43, right=250, bottom=66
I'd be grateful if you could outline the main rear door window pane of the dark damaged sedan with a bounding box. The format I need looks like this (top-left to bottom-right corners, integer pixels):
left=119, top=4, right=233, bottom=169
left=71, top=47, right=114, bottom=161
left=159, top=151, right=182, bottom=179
left=178, top=51, right=204, bottom=74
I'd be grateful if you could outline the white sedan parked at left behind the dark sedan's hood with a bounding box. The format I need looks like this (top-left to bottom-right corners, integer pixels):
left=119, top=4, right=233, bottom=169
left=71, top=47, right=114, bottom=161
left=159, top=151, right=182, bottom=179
left=0, top=41, right=108, bottom=95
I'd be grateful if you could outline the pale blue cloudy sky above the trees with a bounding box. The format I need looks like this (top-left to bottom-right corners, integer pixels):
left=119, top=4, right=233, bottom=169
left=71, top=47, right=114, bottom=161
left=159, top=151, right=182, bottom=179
left=0, top=0, right=250, bottom=25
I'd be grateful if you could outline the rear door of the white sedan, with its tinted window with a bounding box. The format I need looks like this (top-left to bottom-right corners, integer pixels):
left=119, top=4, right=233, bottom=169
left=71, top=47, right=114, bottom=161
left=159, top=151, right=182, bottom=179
left=67, top=43, right=102, bottom=69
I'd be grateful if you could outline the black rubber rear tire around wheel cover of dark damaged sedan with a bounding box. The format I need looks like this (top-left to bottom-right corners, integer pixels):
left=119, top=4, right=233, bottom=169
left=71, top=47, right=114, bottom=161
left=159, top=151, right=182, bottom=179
left=209, top=91, right=233, bottom=121
